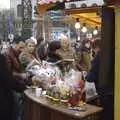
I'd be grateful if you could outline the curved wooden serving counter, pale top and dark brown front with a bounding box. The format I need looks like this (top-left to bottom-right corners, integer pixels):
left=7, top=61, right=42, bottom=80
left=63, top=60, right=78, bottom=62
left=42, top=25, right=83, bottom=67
left=25, top=89, right=102, bottom=120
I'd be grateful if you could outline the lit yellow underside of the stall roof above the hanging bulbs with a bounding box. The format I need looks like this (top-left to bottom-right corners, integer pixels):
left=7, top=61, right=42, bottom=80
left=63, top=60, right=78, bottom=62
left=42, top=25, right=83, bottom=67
left=65, top=7, right=101, bottom=26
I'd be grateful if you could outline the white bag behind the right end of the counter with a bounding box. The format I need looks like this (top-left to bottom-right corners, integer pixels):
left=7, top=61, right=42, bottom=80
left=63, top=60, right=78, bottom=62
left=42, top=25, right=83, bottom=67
left=85, top=81, right=98, bottom=100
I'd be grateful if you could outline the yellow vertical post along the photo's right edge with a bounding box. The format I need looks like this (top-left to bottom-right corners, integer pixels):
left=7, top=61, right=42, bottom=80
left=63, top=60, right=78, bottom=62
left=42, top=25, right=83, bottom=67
left=114, top=5, right=120, bottom=120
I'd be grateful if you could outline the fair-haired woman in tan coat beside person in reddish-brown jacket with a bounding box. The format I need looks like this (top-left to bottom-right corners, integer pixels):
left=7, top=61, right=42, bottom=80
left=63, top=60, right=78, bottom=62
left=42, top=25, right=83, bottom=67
left=19, top=39, right=36, bottom=70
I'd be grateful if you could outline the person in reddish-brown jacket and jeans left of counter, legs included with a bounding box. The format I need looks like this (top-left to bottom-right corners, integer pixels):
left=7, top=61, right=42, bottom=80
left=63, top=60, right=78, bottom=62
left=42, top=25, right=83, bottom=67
left=4, top=39, right=31, bottom=120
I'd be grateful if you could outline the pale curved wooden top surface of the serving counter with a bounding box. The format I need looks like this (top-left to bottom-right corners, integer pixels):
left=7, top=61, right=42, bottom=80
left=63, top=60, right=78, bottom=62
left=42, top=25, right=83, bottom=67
left=25, top=89, right=102, bottom=119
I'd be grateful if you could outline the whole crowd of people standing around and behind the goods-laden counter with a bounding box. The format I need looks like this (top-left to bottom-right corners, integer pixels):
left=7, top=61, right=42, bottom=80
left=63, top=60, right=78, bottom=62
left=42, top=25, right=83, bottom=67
left=0, top=36, right=100, bottom=120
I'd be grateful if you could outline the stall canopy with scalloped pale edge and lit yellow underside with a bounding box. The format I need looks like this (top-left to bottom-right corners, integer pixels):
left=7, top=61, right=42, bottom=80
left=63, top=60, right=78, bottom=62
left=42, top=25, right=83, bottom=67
left=38, top=0, right=104, bottom=26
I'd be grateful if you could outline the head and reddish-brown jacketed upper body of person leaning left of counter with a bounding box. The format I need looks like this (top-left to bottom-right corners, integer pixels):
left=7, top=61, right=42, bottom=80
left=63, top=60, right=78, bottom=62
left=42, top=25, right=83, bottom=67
left=4, top=40, right=28, bottom=82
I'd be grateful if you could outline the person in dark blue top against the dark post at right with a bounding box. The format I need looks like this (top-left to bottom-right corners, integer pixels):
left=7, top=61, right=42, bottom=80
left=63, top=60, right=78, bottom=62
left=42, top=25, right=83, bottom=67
left=86, top=39, right=101, bottom=89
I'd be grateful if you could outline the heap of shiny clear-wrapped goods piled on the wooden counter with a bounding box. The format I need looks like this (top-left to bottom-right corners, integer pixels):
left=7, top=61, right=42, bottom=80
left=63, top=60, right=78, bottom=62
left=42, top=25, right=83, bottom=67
left=28, top=61, right=85, bottom=106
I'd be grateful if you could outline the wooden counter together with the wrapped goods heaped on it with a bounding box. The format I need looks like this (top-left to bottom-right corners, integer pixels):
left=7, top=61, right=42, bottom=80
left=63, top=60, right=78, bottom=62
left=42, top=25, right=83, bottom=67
left=22, top=50, right=102, bottom=120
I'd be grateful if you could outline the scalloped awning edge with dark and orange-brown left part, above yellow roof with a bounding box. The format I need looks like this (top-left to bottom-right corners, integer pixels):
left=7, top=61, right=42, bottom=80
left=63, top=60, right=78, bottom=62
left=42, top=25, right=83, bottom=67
left=37, top=0, right=104, bottom=14
